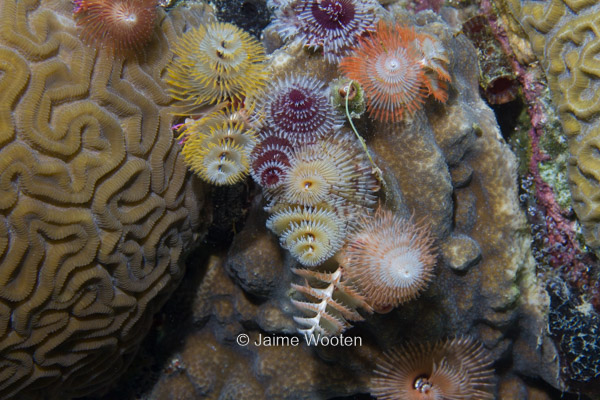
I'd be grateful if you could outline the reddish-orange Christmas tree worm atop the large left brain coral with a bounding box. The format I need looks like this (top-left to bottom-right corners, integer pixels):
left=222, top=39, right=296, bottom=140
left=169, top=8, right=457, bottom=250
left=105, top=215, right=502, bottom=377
left=74, top=0, right=158, bottom=55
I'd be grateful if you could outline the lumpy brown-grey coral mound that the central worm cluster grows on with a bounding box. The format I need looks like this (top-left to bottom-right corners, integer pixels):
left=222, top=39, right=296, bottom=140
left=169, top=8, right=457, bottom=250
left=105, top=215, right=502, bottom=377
left=132, top=8, right=560, bottom=399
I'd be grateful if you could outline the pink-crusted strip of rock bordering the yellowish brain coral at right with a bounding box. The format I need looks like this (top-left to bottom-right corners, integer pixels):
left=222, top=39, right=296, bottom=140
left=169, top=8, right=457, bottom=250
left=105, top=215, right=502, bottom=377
left=481, top=0, right=600, bottom=312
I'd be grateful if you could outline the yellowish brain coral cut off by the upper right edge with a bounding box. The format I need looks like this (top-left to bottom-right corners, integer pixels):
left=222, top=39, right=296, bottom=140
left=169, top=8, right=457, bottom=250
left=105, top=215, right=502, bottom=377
left=507, top=0, right=600, bottom=251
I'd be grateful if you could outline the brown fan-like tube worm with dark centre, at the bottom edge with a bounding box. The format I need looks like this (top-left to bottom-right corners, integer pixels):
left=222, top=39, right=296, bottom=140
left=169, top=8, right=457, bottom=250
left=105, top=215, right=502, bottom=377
left=371, top=338, right=494, bottom=400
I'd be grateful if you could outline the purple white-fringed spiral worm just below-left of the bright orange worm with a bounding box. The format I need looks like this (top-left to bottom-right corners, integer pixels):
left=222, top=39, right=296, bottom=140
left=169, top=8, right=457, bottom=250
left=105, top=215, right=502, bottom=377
left=257, top=75, right=342, bottom=145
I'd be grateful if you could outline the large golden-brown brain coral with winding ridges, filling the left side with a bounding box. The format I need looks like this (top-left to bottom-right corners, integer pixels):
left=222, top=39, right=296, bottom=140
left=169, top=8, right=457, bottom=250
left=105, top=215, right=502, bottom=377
left=0, top=0, right=206, bottom=400
